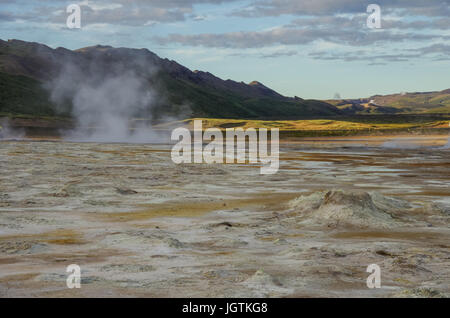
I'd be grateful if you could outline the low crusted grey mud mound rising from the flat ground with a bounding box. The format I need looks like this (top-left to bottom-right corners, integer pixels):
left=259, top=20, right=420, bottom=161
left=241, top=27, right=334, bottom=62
left=288, top=191, right=410, bottom=228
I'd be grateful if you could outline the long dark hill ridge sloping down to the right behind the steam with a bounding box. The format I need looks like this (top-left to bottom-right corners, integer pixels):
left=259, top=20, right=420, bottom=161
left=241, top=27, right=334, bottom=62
left=0, top=40, right=343, bottom=118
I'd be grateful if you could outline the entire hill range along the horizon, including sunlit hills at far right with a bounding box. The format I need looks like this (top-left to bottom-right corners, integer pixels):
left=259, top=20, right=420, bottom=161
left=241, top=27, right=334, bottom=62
left=0, top=40, right=450, bottom=121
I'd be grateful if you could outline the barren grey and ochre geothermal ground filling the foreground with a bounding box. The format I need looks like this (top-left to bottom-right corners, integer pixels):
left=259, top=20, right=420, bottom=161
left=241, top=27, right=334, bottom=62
left=0, top=135, right=450, bottom=297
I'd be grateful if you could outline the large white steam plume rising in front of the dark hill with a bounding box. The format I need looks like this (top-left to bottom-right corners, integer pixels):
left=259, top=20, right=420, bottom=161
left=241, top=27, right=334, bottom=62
left=48, top=50, right=171, bottom=143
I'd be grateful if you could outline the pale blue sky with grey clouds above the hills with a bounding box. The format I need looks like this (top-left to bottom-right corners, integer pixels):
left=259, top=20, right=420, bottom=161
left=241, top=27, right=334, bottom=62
left=0, top=0, right=450, bottom=99
